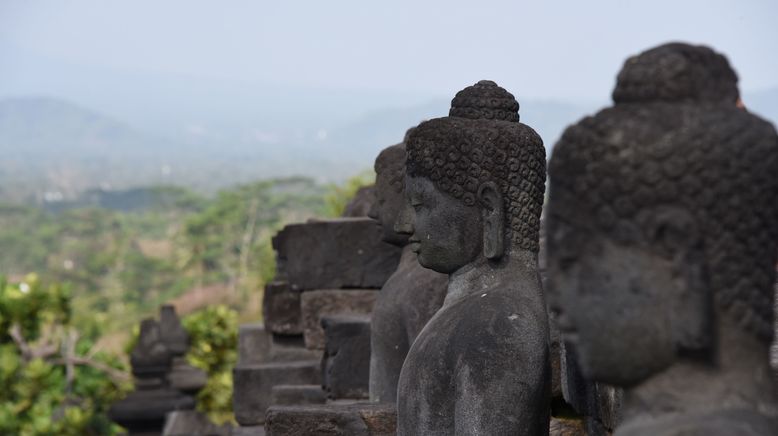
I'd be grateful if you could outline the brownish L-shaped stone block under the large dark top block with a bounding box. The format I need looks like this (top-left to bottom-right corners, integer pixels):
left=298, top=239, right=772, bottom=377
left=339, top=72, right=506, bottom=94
left=301, top=289, right=378, bottom=350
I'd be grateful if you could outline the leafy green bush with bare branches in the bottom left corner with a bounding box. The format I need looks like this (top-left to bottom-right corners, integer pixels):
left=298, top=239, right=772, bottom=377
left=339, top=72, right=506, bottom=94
left=0, top=275, right=129, bottom=435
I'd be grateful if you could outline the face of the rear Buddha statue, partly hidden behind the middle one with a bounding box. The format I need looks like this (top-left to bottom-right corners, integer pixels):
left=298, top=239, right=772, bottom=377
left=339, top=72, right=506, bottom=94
left=368, top=138, right=408, bottom=246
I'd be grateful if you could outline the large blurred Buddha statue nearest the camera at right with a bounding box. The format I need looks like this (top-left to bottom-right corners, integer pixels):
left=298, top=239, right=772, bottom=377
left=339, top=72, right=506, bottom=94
left=547, top=43, right=778, bottom=436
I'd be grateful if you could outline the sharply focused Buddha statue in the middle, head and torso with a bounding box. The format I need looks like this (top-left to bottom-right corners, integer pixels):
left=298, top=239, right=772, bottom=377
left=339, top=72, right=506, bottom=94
left=397, top=81, right=551, bottom=436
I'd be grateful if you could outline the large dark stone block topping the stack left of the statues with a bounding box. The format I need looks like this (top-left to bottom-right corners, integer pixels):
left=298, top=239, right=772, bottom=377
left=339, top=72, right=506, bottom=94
left=273, top=218, right=400, bottom=290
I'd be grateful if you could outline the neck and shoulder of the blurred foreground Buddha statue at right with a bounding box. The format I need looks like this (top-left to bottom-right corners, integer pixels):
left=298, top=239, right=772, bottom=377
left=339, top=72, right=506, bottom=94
left=622, top=315, right=778, bottom=424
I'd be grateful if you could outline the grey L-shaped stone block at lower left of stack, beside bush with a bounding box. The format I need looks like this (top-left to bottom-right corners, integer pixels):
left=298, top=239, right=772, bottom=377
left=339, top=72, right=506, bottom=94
left=232, top=360, right=321, bottom=426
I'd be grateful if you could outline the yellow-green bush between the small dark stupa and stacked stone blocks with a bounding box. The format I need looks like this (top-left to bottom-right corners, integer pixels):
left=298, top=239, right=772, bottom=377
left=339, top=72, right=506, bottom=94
left=182, top=305, right=238, bottom=424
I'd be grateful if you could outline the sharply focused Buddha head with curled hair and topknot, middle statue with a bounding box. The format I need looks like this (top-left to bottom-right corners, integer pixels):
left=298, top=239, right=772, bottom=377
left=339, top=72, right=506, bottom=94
left=406, top=81, right=545, bottom=274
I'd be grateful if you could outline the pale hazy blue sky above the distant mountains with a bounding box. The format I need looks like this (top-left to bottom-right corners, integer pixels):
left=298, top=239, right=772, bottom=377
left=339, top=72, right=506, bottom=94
left=0, top=0, right=778, bottom=101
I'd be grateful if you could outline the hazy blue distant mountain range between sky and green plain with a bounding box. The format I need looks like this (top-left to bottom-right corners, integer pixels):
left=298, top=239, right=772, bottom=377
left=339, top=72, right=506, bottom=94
left=0, top=89, right=778, bottom=202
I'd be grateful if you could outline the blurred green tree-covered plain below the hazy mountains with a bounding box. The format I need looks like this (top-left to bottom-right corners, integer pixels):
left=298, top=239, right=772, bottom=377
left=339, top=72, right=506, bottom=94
left=0, top=178, right=325, bottom=338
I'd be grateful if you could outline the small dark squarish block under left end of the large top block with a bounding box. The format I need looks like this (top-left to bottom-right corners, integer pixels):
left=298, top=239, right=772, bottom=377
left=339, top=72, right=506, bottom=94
left=262, top=282, right=303, bottom=335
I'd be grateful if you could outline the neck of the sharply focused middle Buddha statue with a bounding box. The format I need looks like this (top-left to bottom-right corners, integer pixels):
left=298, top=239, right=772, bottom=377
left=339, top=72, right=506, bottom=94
left=443, top=250, right=540, bottom=307
